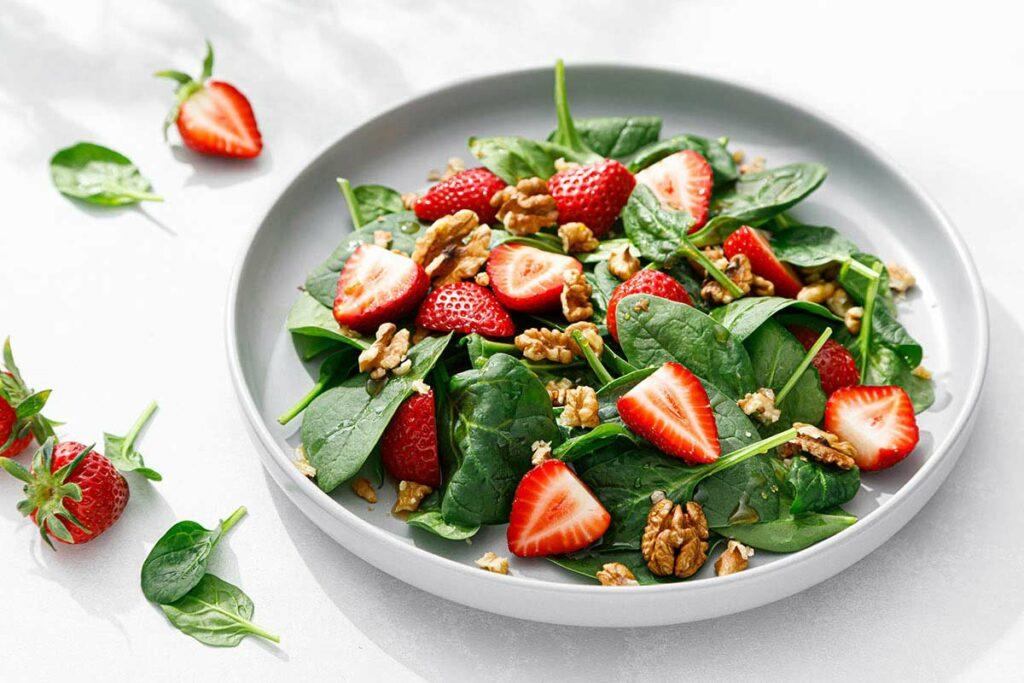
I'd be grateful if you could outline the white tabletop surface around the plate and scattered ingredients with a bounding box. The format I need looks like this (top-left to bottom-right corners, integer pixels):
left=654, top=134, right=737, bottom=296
left=0, top=0, right=1024, bottom=681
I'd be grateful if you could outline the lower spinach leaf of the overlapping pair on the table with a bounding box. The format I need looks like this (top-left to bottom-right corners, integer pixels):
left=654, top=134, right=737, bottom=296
left=160, top=573, right=281, bottom=647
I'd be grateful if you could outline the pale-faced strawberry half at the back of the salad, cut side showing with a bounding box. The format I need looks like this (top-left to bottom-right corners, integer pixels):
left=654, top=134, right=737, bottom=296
left=637, top=150, right=714, bottom=232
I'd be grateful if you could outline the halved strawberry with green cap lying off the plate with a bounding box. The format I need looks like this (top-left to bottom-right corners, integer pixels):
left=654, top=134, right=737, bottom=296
left=155, top=41, right=263, bottom=159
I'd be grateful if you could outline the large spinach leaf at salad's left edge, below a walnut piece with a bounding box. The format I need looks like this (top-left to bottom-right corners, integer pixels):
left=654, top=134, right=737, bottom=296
left=300, top=333, right=452, bottom=493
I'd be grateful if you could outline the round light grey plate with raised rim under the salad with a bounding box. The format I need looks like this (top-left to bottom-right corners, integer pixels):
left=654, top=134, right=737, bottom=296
left=227, top=66, right=988, bottom=626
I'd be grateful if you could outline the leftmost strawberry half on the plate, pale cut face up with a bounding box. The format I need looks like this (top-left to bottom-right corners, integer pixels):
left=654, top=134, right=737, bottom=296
left=334, top=245, right=430, bottom=334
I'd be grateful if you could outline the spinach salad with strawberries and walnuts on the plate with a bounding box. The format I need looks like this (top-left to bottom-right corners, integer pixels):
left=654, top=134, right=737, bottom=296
left=280, top=61, right=933, bottom=586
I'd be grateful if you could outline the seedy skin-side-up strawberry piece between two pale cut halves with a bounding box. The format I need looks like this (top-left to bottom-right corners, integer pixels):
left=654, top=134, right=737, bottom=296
left=416, top=282, right=515, bottom=337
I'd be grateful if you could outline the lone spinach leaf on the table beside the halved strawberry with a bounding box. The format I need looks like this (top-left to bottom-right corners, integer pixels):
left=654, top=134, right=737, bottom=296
left=50, top=142, right=164, bottom=206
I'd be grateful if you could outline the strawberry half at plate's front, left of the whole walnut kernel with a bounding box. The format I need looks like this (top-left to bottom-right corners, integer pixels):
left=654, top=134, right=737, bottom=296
left=508, top=460, right=611, bottom=557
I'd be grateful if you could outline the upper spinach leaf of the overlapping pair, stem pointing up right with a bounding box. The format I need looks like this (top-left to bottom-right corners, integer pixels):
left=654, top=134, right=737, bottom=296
left=142, top=507, right=246, bottom=604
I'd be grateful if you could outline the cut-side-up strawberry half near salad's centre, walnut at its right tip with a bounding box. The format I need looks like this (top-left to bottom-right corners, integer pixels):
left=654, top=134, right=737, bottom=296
left=487, top=243, right=583, bottom=313
